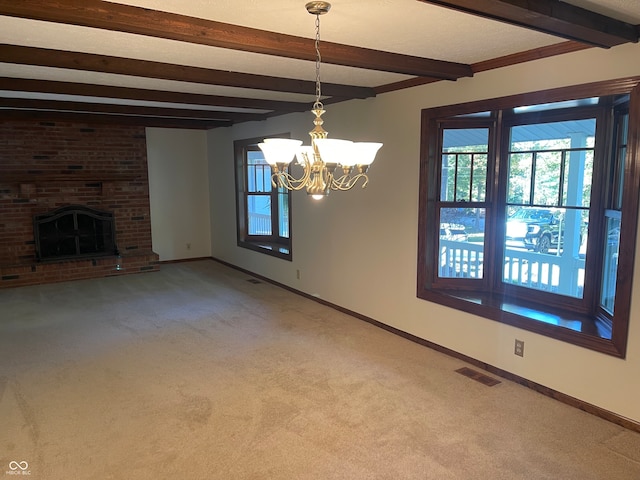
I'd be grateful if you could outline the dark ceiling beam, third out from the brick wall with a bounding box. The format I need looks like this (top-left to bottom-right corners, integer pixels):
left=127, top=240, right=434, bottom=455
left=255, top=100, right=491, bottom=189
left=0, top=77, right=311, bottom=112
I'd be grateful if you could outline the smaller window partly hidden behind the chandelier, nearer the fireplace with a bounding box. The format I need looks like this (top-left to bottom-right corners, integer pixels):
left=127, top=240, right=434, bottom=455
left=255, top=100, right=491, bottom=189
left=234, top=138, right=291, bottom=260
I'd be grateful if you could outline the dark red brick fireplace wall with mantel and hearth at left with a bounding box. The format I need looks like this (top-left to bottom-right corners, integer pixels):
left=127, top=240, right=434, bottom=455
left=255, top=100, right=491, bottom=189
left=0, top=121, right=158, bottom=288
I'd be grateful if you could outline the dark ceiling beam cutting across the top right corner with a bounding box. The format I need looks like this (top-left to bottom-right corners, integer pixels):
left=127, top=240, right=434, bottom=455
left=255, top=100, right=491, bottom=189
left=419, top=0, right=638, bottom=48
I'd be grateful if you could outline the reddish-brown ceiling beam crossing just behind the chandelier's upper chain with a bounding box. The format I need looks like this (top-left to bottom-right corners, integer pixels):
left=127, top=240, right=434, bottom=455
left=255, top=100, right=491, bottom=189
left=0, top=0, right=473, bottom=80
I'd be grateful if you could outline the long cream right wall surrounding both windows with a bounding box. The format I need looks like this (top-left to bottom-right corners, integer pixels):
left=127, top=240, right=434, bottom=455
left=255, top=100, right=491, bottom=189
left=208, top=44, right=640, bottom=422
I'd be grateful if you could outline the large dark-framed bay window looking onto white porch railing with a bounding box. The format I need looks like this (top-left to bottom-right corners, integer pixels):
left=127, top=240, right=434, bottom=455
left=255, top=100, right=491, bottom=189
left=418, top=78, right=640, bottom=357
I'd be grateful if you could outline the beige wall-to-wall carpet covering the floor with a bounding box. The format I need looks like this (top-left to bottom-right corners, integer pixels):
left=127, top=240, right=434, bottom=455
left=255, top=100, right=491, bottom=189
left=0, top=261, right=640, bottom=480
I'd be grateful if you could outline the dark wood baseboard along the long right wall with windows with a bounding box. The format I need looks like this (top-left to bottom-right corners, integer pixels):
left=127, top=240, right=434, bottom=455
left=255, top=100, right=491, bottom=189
left=207, top=257, right=640, bottom=433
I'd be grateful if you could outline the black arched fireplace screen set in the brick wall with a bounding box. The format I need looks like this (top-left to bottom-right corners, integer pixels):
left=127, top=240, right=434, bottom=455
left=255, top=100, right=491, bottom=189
left=33, top=205, right=118, bottom=260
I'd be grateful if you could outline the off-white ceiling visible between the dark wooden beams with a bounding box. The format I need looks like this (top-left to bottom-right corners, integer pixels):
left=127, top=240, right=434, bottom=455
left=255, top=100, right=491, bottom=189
left=0, top=0, right=640, bottom=127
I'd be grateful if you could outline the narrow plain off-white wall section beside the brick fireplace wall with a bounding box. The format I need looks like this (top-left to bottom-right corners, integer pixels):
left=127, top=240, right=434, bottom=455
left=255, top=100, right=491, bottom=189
left=147, top=128, right=211, bottom=260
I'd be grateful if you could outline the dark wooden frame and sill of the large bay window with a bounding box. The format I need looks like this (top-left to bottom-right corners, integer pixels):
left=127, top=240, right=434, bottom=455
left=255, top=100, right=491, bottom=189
left=417, top=77, right=640, bottom=358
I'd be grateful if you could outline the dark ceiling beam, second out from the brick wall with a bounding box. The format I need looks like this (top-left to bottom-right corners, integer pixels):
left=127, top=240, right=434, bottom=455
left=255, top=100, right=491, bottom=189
left=0, top=98, right=265, bottom=125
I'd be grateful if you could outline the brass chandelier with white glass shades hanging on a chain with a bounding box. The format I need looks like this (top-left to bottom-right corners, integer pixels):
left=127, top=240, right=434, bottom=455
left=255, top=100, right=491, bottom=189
left=258, top=2, right=382, bottom=200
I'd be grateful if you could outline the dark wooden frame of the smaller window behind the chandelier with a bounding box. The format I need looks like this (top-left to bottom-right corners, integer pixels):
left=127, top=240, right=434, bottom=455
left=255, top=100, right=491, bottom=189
left=233, top=134, right=293, bottom=261
